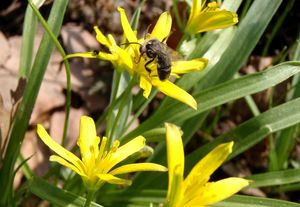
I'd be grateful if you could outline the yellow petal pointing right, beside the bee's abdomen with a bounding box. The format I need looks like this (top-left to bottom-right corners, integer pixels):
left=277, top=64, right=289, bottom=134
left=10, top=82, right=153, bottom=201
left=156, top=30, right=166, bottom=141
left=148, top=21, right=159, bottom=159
left=171, top=58, right=208, bottom=74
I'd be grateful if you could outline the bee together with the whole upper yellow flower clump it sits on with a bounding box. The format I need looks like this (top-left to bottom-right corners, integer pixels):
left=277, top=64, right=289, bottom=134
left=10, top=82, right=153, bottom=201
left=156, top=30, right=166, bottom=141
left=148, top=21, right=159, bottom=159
left=65, top=8, right=208, bottom=109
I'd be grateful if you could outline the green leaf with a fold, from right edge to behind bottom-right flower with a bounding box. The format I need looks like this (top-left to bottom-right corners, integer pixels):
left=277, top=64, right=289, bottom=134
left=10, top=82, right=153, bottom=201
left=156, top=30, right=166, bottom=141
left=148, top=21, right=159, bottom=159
left=186, top=98, right=300, bottom=172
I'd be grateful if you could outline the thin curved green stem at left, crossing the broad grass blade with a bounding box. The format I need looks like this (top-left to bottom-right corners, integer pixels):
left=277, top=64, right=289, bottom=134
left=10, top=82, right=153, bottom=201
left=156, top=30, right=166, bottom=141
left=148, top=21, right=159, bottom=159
left=28, top=0, right=71, bottom=146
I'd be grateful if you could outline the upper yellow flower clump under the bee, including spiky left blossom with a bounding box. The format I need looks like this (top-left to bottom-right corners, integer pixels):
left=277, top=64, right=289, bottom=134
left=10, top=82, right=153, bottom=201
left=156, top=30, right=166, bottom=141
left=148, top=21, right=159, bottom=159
left=66, top=8, right=207, bottom=109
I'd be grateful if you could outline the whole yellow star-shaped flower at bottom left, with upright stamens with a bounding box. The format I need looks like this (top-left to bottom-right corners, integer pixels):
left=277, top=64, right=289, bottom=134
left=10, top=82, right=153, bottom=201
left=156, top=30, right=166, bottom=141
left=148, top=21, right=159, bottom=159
left=37, top=116, right=167, bottom=190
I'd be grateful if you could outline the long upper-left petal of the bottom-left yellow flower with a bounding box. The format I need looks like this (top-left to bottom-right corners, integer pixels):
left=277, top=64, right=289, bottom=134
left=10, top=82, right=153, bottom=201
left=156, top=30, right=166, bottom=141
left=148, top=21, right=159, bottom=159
left=37, top=124, right=84, bottom=172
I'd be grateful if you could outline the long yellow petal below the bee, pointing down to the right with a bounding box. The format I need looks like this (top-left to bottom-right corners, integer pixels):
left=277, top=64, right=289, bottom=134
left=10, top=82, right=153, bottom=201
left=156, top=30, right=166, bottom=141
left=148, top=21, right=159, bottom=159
left=152, top=80, right=197, bottom=110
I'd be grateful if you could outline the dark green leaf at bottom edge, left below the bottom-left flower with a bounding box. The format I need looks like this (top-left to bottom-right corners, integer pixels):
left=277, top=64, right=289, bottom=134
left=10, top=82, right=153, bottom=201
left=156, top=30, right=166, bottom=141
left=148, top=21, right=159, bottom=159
left=28, top=177, right=101, bottom=207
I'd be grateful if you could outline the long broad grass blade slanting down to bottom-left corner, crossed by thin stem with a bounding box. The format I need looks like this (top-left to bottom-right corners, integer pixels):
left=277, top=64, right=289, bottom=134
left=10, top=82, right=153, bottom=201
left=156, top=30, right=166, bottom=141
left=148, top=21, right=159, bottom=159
left=0, top=1, right=68, bottom=206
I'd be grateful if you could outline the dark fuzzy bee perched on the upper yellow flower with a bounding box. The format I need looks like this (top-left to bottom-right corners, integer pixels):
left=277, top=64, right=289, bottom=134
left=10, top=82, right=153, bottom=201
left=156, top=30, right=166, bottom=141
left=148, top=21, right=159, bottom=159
left=125, top=38, right=171, bottom=81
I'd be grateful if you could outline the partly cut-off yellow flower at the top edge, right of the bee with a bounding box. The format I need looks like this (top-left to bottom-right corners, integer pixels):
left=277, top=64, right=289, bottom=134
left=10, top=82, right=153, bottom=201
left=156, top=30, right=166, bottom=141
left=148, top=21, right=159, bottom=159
left=185, top=0, right=238, bottom=34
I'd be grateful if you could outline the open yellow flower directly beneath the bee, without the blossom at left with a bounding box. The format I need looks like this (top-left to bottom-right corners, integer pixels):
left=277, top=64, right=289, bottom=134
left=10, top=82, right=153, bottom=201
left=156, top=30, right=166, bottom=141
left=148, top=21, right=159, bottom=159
left=118, top=8, right=207, bottom=109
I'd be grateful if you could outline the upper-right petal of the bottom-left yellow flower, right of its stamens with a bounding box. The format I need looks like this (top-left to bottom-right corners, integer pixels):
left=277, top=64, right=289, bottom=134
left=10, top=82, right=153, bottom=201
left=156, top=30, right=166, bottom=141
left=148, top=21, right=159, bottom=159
left=107, top=136, right=146, bottom=169
